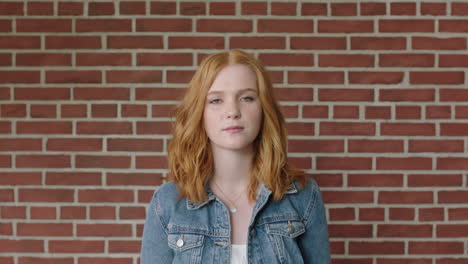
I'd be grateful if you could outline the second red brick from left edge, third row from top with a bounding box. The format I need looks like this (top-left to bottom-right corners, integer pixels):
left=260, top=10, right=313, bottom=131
left=45, top=36, right=101, bottom=49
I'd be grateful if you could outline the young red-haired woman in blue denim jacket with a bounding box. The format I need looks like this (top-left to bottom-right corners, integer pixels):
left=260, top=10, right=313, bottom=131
left=141, top=50, right=330, bottom=264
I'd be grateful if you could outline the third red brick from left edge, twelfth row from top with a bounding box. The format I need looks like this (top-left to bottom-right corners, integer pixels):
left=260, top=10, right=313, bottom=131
left=78, top=189, right=133, bottom=203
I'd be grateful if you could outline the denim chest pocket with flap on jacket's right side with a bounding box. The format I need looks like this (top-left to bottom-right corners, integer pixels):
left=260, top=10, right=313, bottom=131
left=265, top=220, right=306, bottom=263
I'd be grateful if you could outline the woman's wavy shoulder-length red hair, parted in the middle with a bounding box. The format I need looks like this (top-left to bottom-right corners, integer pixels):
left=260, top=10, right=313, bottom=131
left=168, top=50, right=307, bottom=202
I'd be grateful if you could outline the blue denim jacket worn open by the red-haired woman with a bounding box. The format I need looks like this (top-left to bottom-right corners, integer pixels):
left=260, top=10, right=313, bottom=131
left=141, top=179, right=331, bottom=264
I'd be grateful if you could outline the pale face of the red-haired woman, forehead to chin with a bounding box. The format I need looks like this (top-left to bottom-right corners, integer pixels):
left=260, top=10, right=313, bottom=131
left=203, top=64, right=262, bottom=153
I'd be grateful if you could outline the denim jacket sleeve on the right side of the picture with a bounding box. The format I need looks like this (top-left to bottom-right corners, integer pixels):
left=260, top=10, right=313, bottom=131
left=298, top=179, right=331, bottom=264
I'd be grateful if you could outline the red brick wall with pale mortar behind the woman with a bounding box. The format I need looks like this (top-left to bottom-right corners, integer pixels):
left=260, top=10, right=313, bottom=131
left=0, top=0, right=468, bottom=264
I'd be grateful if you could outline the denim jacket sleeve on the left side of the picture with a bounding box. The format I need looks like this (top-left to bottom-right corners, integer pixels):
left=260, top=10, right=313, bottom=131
left=140, top=189, right=174, bottom=264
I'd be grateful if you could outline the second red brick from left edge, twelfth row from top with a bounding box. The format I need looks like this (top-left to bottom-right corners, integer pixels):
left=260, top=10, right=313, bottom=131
left=19, top=188, right=75, bottom=203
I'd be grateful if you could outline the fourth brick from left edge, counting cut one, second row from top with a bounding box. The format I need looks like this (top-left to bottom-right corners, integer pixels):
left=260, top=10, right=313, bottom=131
left=136, top=18, right=192, bottom=32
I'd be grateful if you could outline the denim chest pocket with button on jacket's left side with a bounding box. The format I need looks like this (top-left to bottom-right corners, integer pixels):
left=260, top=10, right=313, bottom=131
left=167, top=232, right=205, bottom=264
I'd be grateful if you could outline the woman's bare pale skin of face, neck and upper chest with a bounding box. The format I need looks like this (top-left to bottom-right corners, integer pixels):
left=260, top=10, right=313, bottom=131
left=203, top=64, right=262, bottom=244
